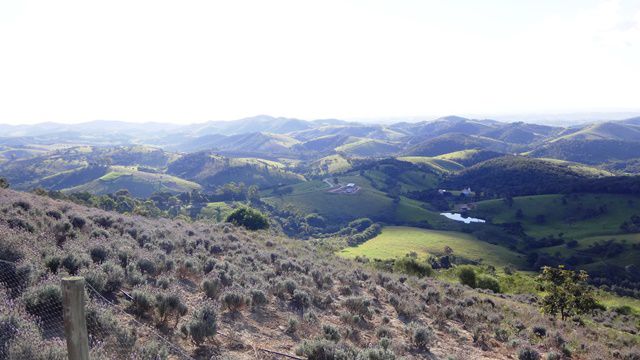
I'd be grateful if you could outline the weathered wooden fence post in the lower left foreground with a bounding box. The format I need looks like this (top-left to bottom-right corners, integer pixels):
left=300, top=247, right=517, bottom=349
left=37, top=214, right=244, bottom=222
left=62, top=276, right=89, bottom=360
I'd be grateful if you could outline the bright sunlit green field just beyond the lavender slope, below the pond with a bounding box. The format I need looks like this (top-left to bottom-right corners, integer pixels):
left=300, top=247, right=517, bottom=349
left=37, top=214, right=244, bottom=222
left=339, top=226, right=525, bottom=267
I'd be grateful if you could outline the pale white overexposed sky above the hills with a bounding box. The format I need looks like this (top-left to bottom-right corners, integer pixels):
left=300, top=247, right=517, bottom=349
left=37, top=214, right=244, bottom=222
left=0, top=0, right=640, bottom=123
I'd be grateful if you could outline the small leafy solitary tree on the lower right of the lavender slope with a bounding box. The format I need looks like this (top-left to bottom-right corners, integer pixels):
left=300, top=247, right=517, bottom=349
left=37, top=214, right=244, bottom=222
left=537, top=265, right=597, bottom=320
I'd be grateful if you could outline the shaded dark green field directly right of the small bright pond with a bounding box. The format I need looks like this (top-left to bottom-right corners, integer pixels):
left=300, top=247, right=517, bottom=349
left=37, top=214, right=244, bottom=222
left=470, top=194, right=640, bottom=239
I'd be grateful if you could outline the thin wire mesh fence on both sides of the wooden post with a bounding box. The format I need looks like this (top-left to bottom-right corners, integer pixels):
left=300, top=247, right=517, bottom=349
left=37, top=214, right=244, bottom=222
left=0, top=260, right=192, bottom=360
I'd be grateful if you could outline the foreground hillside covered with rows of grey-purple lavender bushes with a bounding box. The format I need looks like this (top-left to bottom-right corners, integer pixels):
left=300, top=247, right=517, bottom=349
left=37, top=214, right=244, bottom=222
left=0, top=189, right=634, bottom=360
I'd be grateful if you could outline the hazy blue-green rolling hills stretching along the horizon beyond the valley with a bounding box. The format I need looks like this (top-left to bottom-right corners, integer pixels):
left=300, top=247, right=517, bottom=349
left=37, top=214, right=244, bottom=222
left=0, top=115, right=640, bottom=194
